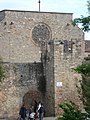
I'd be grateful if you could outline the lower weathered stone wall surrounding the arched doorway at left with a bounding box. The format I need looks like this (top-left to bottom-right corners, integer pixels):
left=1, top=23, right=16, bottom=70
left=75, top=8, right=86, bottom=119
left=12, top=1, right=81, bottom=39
left=0, top=63, right=43, bottom=116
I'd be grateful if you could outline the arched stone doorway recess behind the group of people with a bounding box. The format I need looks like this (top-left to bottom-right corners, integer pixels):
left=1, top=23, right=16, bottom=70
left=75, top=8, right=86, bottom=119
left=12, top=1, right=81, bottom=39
left=23, top=90, right=42, bottom=109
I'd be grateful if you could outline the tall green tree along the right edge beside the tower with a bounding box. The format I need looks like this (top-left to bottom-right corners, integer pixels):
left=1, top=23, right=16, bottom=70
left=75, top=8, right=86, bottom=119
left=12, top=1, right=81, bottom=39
left=74, top=63, right=90, bottom=118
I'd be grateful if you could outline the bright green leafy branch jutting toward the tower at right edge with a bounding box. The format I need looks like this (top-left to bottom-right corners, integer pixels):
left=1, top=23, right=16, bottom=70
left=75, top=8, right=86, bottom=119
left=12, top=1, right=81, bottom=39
left=74, top=64, right=90, bottom=76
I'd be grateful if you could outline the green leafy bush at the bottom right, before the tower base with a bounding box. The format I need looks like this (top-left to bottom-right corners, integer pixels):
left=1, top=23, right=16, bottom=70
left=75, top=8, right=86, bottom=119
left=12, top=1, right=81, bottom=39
left=57, top=102, right=87, bottom=120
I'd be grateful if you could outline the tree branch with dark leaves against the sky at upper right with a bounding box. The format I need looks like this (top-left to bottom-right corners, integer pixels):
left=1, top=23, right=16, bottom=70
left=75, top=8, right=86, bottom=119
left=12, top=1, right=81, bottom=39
left=73, top=0, right=90, bottom=32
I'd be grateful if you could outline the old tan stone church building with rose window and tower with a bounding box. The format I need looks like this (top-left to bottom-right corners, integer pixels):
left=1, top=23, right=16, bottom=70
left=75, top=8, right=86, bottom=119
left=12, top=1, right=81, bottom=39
left=0, top=10, right=85, bottom=117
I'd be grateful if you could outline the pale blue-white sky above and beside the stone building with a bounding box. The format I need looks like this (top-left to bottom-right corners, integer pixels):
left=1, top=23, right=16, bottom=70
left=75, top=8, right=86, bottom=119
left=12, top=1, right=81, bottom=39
left=0, top=0, right=90, bottom=40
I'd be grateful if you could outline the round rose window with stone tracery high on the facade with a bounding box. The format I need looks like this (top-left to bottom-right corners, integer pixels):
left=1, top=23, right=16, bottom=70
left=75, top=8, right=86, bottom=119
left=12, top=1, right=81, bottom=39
left=32, top=23, right=50, bottom=43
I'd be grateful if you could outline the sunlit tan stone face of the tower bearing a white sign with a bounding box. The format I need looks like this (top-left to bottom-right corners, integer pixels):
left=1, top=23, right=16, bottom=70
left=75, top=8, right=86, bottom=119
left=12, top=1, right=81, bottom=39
left=54, top=27, right=85, bottom=115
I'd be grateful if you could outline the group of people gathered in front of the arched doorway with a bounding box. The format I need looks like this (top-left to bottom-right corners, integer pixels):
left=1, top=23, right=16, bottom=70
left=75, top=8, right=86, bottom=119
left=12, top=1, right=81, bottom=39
left=19, top=101, right=44, bottom=120
